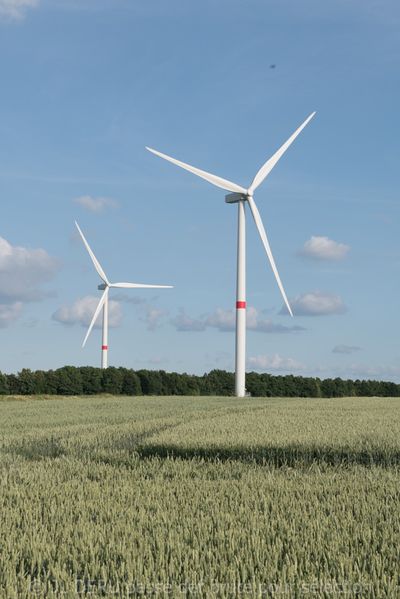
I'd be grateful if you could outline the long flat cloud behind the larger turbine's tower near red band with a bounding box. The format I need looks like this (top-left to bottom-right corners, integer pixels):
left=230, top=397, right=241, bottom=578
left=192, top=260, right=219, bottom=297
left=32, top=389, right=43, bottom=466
left=171, top=306, right=304, bottom=333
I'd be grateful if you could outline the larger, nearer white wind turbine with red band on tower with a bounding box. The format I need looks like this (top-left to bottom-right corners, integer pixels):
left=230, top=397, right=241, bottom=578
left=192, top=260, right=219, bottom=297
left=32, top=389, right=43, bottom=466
left=146, top=112, right=315, bottom=397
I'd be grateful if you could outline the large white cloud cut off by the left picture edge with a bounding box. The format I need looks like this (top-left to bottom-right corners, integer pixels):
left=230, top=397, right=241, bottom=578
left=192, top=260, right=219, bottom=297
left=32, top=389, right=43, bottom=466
left=0, top=237, right=59, bottom=303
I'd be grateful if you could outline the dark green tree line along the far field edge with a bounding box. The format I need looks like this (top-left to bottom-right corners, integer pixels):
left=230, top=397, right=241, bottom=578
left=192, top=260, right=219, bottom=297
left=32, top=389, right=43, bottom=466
left=0, top=366, right=400, bottom=397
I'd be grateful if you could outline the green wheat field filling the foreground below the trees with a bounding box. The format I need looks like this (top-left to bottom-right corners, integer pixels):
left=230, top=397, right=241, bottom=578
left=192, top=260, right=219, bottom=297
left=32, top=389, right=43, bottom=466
left=0, top=397, right=400, bottom=599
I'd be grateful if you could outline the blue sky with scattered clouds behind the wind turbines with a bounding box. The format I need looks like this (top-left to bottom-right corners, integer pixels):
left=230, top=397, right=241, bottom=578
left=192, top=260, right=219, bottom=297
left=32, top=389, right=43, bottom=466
left=0, top=0, right=400, bottom=381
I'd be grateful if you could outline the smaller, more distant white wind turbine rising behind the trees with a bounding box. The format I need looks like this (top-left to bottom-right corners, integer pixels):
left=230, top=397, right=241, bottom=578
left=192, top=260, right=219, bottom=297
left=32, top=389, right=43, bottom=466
left=75, top=221, right=172, bottom=368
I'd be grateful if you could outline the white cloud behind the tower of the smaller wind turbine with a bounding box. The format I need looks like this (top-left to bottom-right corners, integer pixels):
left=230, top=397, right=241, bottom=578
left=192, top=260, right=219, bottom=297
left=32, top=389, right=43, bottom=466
left=52, top=295, right=122, bottom=327
